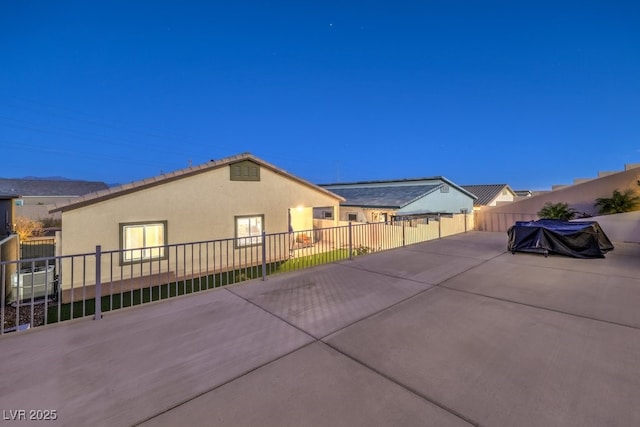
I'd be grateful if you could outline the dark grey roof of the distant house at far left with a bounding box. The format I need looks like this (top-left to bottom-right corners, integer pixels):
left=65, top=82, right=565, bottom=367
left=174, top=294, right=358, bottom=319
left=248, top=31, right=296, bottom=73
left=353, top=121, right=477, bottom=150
left=0, top=178, right=109, bottom=197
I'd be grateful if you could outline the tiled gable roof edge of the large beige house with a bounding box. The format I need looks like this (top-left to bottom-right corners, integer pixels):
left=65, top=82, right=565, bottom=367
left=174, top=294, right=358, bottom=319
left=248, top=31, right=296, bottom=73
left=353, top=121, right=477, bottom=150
left=49, top=153, right=344, bottom=213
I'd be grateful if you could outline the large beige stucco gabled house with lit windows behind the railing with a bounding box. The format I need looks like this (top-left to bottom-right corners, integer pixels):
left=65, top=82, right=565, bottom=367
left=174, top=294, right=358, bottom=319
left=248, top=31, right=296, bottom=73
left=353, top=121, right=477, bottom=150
left=51, top=153, right=342, bottom=287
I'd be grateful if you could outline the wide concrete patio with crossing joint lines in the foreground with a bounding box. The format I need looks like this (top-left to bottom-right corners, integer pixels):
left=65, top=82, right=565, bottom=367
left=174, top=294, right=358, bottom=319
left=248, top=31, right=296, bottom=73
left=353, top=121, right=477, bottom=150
left=0, top=232, right=640, bottom=427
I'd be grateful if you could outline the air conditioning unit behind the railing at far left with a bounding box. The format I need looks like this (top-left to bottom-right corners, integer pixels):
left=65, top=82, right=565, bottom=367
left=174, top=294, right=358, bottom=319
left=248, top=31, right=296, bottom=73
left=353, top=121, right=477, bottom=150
left=8, top=265, right=56, bottom=303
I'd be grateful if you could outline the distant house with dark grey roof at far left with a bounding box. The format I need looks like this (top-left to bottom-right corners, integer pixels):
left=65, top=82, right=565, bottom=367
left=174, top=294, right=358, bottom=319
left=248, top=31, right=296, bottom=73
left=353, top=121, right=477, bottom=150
left=0, top=178, right=109, bottom=220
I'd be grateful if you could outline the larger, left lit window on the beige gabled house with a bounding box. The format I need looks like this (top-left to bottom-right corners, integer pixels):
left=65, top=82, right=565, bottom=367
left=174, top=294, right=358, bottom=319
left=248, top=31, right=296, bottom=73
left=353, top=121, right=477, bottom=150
left=120, top=221, right=167, bottom=263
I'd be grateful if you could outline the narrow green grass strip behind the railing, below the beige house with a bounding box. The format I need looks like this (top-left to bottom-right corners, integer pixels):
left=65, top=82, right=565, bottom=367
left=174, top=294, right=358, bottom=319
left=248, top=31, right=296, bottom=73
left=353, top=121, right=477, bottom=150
left=47, top=249, right=349, bottom=323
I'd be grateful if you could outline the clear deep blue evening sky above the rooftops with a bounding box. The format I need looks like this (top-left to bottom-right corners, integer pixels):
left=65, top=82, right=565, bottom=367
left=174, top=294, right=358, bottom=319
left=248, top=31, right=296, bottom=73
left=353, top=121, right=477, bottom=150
left=0, top=0, right=640, bottom=189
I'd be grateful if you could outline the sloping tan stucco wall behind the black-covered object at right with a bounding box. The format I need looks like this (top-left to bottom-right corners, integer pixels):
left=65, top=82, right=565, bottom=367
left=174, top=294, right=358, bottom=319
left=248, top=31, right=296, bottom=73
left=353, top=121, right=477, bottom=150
left=476, top=168, right=640, bottom=232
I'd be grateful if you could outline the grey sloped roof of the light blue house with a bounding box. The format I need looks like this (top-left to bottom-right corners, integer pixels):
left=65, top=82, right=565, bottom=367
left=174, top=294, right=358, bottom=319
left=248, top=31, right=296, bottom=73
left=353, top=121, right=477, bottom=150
left=324, top=184, right=443, bottom=209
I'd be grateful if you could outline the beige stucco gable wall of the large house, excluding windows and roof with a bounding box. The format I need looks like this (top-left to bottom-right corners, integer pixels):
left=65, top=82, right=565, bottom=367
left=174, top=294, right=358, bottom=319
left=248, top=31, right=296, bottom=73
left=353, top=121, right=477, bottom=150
left=60, top=166, right=339, bottom=288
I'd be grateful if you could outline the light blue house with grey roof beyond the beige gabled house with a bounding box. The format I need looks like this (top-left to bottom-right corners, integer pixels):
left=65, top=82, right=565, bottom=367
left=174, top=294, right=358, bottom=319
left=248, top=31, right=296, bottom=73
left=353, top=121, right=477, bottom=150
left=314, top=176, right=476, bottom=222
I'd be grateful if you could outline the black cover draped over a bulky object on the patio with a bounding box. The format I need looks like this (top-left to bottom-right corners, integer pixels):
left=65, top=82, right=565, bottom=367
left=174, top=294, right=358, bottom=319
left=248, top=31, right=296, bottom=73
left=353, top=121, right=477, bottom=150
left=507, top=219, right=613, bottom=258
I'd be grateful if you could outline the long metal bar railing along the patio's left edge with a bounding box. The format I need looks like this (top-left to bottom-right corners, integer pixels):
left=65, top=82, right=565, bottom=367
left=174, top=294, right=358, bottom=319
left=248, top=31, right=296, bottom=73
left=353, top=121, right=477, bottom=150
left=0, top=215, right=470, bottom=334
